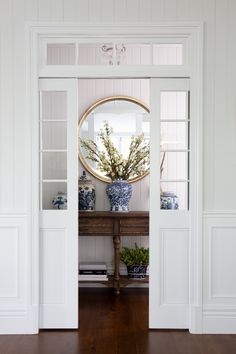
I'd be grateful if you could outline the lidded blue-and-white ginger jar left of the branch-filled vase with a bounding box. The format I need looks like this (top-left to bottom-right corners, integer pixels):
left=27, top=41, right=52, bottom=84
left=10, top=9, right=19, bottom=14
left=79, top=171, right=96, bottom=211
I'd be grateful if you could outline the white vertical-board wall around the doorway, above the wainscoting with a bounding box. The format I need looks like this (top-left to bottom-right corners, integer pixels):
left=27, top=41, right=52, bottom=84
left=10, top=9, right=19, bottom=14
left=0, top=0, right=236, bottom=209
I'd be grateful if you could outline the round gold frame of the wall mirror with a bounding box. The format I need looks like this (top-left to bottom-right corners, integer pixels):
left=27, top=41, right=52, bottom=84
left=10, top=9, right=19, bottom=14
left=78, top=95, right=150, bottom=183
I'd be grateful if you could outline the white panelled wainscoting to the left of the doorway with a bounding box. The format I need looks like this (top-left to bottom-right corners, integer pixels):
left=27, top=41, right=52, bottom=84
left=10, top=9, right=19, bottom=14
left=0, top=210, right=38, bottom=334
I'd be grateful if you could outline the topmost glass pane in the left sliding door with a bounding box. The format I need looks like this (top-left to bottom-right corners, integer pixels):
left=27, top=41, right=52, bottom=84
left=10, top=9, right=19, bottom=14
left=41, top=91, right=67, bottom=120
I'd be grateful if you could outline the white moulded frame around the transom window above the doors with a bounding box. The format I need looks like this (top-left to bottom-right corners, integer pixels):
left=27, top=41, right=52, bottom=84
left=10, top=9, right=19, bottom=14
left=27, top=22, right=203, bottom=81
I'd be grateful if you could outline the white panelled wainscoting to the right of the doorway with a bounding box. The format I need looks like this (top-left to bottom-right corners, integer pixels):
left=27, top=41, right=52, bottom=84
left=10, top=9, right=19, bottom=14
left=203, top=211, right=236, bottom=333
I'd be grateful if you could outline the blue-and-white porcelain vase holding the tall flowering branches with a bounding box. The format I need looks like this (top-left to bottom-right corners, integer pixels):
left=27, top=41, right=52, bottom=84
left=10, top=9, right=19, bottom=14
left=106, top=180, right=132, bottom=211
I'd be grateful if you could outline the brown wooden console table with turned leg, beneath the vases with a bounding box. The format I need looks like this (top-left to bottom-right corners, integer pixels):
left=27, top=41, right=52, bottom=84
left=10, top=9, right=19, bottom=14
left=79, top=211, right=149, bottom=294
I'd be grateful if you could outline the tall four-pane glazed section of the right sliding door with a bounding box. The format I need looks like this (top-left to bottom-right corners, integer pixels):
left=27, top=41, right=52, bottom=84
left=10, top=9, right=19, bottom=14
left=160, top=89, right=190, bottom=210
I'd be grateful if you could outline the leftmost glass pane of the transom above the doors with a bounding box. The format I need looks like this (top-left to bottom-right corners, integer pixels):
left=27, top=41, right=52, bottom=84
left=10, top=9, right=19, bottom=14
left=47, top=43, right=76, bottom=65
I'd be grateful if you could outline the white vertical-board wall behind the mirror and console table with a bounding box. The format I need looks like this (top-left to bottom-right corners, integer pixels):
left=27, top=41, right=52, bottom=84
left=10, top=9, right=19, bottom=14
left=78, top=79, right=149, bottom=272
